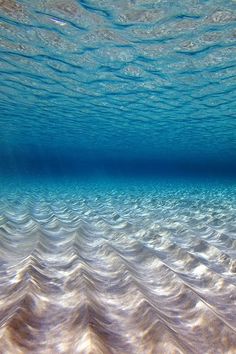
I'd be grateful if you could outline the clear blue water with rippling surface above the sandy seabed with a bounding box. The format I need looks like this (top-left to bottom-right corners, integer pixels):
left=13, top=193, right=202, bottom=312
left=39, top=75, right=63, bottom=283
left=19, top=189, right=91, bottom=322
left=0, top=0, right=236, bottom=174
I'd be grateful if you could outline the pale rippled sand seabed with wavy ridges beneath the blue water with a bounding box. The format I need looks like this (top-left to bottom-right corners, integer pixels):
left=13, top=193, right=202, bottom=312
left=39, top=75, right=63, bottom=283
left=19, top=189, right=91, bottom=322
left=0, top=186, right=236, bottom=354
